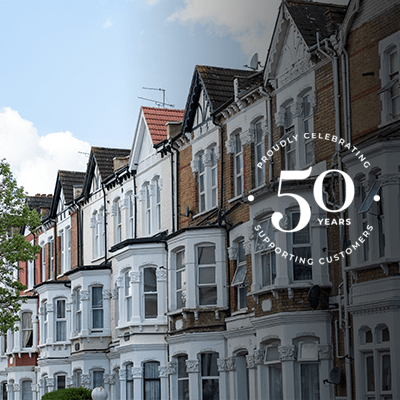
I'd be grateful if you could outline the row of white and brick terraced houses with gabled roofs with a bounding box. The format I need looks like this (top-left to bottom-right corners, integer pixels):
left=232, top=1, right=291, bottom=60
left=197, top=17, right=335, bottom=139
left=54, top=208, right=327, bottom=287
left=0, top=0, right=400, bottom=400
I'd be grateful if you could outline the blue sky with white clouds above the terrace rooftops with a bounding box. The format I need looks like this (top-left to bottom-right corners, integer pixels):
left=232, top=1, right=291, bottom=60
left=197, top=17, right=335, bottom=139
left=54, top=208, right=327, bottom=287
left=0, top=0, right=347, bottom=195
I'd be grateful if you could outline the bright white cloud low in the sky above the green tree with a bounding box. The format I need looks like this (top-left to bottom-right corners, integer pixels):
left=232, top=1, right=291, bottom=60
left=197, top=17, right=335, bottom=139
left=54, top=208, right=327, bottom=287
left=0, top=107, right=90, bottom=195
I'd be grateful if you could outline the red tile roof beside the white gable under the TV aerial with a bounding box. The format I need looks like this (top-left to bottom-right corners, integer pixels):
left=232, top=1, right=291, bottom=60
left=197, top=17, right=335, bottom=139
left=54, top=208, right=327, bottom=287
left=142, top=107, right=185, bottom=144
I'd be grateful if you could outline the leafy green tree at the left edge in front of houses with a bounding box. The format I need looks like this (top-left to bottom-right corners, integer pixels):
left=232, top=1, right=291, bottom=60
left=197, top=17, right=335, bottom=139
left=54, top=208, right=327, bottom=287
left=0, top=159, right=40, bottom=334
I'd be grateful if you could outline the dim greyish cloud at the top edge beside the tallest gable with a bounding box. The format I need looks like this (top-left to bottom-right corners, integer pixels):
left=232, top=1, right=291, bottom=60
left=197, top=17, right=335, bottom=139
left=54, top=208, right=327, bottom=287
left=168, top=0, right=348, bottom=59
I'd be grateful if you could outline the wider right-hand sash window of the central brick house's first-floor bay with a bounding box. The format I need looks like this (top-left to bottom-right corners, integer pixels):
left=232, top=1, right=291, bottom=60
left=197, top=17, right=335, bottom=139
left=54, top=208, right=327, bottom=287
left=197, top=246, right=217, bottom=306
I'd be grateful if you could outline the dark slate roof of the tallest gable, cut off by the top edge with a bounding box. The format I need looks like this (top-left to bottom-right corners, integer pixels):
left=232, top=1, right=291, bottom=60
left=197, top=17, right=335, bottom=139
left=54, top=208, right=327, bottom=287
left=284, top=1, right=346, bottom=47
